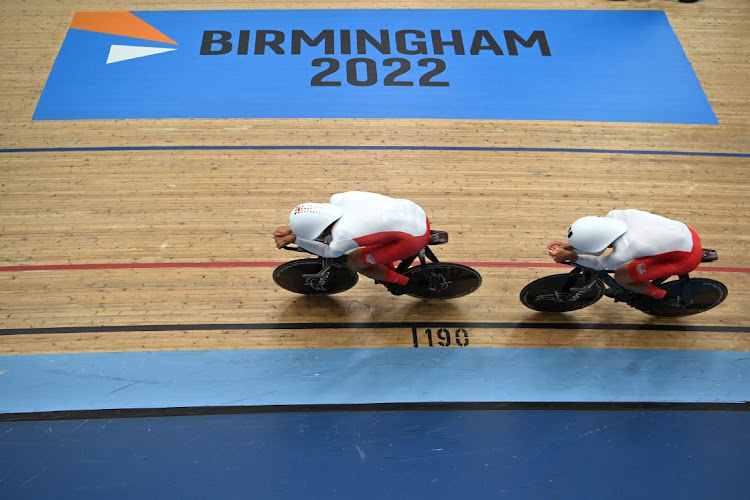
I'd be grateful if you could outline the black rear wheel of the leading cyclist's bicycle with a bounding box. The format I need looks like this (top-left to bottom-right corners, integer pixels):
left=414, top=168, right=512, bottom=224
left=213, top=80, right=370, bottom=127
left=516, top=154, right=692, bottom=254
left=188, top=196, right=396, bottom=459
left=404, top=262, right=482, bottom=299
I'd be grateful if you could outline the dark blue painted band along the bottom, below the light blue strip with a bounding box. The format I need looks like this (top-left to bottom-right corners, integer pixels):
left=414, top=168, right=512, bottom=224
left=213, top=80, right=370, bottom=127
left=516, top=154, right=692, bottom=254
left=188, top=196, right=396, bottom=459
left=0, top=410, right=750, bottom=500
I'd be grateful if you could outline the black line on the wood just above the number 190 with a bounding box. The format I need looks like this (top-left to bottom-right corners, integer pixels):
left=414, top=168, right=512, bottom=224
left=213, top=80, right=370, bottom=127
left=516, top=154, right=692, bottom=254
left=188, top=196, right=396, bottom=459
left=0, top=320, right=750, bottom=336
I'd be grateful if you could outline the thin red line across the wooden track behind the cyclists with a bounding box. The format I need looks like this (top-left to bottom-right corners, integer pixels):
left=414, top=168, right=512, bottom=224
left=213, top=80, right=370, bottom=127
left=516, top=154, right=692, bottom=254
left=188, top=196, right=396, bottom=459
left=0, top=262, right=750, bottom=273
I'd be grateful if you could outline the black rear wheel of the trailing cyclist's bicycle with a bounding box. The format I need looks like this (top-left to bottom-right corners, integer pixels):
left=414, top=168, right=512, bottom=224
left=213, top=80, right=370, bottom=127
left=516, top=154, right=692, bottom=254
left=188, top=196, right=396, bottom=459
left=633, top=278, right=729, bottom=318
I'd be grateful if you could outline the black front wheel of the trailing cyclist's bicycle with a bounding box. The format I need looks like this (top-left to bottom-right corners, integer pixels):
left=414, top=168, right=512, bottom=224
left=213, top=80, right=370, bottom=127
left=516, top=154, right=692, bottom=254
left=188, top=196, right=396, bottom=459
left=520, top=273, right=604, bottom=312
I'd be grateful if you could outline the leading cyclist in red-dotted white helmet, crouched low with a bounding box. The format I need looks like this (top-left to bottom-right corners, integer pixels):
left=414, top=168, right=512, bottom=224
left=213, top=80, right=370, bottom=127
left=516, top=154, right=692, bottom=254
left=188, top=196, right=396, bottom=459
left=273, top=191, right=430, bottom=294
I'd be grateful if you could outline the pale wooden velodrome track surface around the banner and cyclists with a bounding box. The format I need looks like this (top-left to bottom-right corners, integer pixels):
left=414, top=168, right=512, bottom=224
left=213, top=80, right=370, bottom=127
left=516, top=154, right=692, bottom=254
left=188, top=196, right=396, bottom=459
left=0, top=0, right=750, bottom=355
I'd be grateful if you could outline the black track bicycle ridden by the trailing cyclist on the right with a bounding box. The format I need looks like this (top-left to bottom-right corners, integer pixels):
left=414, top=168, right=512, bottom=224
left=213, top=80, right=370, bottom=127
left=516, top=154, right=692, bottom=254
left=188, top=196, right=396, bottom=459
left=520, top=249, right=728, bottom=318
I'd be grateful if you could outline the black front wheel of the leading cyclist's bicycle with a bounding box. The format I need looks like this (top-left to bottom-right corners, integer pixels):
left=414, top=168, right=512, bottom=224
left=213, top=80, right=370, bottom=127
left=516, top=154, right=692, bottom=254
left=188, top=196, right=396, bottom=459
left=273, top=259, right=359, bottom=295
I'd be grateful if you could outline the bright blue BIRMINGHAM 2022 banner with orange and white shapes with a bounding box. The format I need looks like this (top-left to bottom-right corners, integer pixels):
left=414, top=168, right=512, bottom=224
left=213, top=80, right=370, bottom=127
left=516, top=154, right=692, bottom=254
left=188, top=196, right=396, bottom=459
left=34, top=10, right=718, bottom=124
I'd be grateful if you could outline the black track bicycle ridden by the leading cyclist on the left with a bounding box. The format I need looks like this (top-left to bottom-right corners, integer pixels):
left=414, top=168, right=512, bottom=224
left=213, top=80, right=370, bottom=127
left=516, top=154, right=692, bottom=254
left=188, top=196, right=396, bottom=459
left=273, top=230, right=482, bottom=300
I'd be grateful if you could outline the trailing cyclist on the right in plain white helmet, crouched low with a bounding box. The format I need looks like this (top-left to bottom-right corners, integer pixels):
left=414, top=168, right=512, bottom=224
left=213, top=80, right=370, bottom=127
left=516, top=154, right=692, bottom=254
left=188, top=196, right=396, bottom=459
left=547, top=209, right=703, bottom=299
